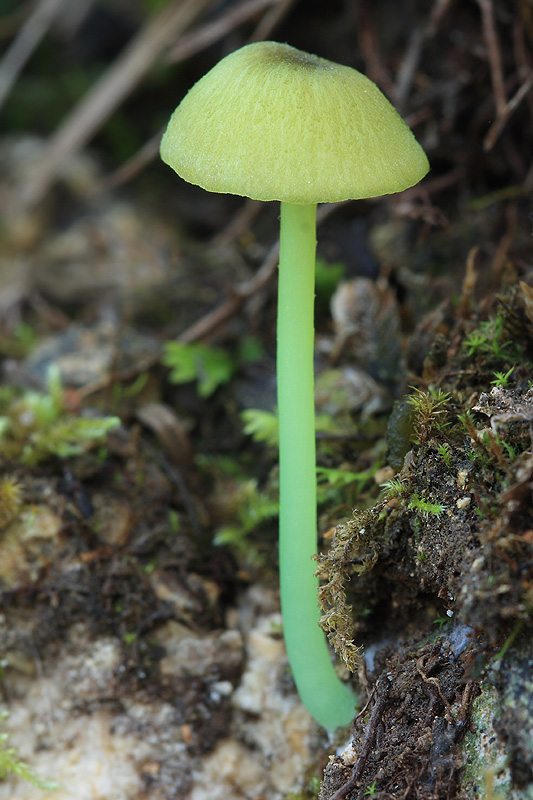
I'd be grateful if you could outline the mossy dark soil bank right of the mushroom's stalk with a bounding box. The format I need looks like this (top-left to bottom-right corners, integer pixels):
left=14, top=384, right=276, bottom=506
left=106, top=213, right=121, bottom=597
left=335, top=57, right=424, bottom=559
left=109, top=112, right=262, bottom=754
left=320, top=278, right=533, bottom=800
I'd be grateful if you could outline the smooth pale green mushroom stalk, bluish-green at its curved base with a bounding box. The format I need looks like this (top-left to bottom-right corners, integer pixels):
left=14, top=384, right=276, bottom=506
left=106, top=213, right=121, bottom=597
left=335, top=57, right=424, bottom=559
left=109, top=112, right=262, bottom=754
left=277, top=203, right=355, bottom=730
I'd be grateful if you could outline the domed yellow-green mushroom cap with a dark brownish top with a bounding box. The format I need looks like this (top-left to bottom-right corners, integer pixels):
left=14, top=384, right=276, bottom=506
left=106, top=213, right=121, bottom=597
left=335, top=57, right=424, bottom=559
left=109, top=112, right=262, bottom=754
left=161, top=42, right=429, bottom=203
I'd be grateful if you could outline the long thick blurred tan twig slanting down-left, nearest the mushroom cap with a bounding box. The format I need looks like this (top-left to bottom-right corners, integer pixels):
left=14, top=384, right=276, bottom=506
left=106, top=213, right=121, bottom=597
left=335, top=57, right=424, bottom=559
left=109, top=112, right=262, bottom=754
left=19, top=0, right=212, bottom=210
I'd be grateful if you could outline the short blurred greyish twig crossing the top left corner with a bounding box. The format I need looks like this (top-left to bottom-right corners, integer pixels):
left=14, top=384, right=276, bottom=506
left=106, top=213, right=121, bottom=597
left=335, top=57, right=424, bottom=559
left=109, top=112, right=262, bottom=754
left=0, top=0, right=65, bottom=108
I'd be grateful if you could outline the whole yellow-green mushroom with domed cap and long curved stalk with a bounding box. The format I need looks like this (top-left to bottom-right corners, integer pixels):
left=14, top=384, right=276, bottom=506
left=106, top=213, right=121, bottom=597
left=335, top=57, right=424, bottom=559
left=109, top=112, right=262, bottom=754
left=161, top=42, right=429, bottom=730
